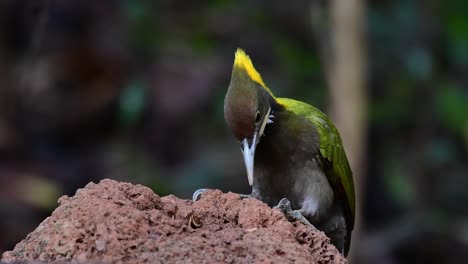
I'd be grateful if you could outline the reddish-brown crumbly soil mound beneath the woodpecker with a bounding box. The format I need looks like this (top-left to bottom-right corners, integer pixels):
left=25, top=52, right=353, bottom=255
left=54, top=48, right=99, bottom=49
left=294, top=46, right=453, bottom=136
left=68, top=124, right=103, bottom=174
left=2, top=180, right=346, bottom=263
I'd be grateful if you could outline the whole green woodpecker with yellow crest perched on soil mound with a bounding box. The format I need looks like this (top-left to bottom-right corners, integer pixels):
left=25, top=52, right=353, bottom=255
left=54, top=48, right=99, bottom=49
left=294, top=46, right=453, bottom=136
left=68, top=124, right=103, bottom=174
left=194, top=49, right=355, bottom=256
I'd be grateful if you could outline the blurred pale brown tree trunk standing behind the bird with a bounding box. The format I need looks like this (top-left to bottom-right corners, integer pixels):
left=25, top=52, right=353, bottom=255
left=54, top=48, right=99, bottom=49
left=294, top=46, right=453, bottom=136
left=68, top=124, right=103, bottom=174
left=312, top=0, right=367, bottom=262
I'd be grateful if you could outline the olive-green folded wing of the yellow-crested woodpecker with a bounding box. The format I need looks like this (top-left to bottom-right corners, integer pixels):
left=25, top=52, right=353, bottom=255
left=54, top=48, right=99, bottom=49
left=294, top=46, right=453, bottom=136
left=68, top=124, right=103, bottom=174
left=277, top=98, right=356, bottom=230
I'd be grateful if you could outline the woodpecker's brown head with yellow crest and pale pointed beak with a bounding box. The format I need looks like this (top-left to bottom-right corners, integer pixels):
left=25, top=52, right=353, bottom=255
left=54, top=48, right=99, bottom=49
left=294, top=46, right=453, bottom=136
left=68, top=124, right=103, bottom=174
left=224, top=49, right=274, bottom=185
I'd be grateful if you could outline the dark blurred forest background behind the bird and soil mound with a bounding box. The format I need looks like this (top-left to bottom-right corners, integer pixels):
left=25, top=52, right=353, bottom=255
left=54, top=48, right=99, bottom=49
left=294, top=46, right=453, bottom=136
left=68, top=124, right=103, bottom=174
left=0, top=0, right=468, bottom=263
